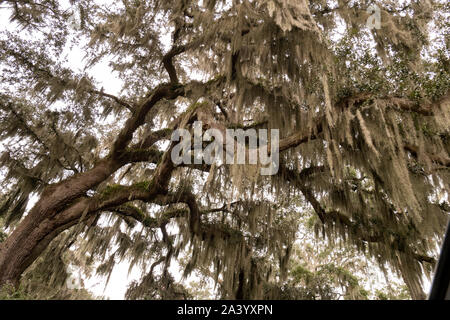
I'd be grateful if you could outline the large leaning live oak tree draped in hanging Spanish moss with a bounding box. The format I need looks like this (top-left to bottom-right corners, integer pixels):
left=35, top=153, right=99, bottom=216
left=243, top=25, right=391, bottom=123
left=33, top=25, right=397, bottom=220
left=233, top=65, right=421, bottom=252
left=0, top=0, right=450, bottom=299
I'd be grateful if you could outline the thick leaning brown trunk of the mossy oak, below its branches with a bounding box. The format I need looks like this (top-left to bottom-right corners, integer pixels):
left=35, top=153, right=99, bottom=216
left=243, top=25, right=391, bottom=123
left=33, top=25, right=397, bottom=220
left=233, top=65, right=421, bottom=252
left=0, top=159, right=120, bottom=286
